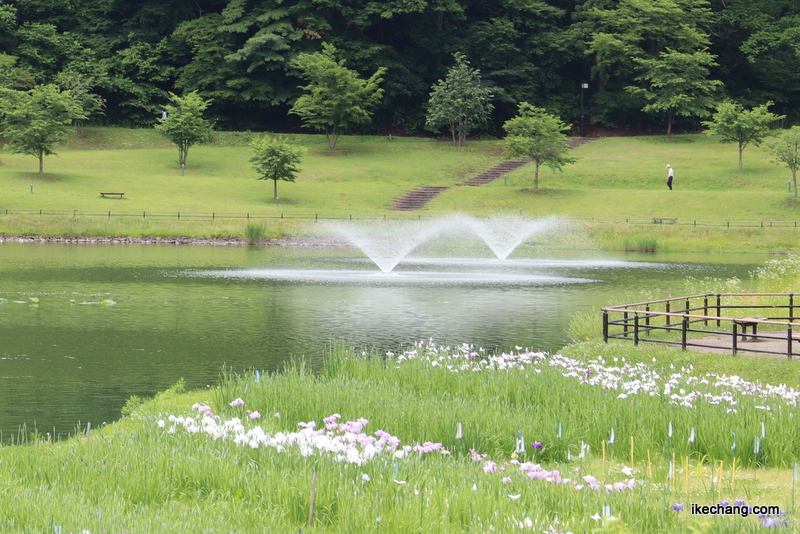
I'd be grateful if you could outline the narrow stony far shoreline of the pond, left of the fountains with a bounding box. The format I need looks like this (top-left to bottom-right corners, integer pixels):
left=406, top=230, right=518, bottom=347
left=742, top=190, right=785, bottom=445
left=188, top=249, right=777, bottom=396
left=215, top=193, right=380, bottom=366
left=0, top=235, right=350, bottom=248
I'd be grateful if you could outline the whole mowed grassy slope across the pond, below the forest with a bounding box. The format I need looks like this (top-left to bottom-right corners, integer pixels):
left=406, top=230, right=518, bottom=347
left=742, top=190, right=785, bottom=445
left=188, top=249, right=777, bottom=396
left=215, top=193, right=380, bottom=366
left=0, top=128, right=800, bottom=252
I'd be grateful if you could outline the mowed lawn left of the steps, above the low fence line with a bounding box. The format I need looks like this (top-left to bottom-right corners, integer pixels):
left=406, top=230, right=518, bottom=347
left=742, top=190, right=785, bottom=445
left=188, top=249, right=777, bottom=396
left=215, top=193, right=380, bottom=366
left=0, top=129, right=502, bottom=213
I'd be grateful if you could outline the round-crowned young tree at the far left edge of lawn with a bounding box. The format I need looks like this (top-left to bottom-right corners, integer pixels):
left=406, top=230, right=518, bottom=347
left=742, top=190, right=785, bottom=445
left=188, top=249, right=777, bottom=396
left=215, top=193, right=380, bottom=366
left=0, top=85, right=86, bottom=174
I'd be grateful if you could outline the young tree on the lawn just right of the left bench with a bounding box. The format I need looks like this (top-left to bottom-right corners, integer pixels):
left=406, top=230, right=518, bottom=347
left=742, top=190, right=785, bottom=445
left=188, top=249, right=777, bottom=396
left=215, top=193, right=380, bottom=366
left=155, top=91, right=214, bottom=165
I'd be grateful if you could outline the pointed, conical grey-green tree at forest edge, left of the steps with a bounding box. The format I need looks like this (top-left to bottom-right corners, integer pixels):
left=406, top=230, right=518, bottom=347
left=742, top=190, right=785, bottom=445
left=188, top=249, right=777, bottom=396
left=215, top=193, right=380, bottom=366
left=426, top=53, right=494, bottom=146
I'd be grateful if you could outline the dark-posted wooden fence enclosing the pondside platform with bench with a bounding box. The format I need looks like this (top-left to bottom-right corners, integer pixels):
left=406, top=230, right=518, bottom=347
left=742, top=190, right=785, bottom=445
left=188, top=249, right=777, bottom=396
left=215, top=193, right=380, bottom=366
left=603, top=293, right=800, bottom=359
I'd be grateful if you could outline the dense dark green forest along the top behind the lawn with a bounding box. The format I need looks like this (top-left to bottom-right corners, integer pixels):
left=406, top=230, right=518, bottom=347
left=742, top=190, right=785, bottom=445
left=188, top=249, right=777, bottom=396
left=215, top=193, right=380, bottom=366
left=0, top=0, right=800, bottom=135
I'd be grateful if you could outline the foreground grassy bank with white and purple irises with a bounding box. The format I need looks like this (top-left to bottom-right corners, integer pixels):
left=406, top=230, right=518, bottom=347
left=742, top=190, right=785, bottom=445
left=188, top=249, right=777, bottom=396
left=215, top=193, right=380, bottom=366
left=0, top=344, right=800, bottom=533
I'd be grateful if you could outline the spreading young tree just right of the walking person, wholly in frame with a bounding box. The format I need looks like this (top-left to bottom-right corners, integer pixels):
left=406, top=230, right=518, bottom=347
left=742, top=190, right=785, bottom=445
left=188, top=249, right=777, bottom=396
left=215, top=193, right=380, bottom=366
left=703, top=101, right=783, bottom=170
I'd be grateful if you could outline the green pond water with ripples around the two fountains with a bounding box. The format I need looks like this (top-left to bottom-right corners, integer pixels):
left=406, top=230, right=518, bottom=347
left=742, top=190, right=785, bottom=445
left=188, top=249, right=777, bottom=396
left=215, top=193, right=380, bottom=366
left=0, top=243, right=765, bottom=441
